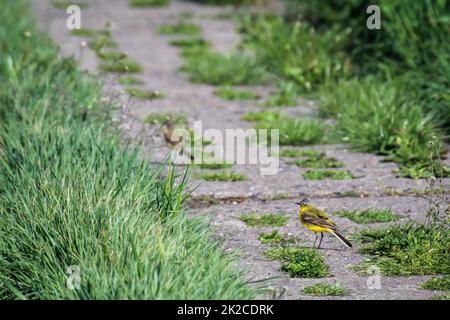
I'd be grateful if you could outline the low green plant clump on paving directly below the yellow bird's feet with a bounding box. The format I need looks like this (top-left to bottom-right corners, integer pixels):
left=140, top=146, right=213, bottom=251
left=264, top=246, right=328, bottom=278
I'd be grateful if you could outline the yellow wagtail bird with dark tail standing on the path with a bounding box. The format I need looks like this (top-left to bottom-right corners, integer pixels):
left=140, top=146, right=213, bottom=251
left=295, top=199, right=352, bottom=248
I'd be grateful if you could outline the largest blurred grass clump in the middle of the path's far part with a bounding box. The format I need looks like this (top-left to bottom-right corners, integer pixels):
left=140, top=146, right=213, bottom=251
left=181, top=48, right=266, bottom=85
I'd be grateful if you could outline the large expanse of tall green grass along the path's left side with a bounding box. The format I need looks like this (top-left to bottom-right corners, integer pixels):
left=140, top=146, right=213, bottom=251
left=0, top=0, right=254, bottom=300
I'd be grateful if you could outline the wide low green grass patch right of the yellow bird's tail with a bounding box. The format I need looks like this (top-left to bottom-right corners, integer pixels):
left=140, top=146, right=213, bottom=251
left=354, top=224, right=450, bottom=275
